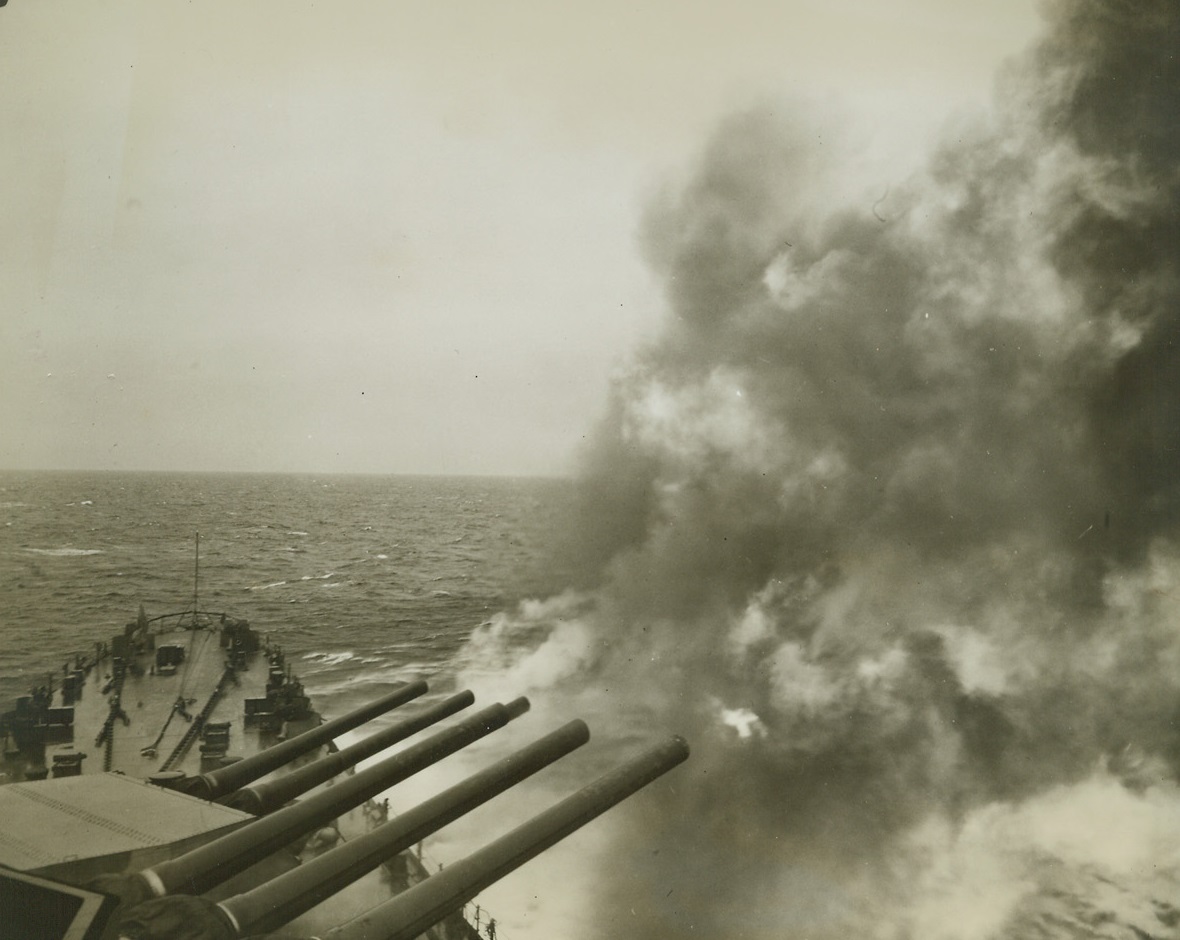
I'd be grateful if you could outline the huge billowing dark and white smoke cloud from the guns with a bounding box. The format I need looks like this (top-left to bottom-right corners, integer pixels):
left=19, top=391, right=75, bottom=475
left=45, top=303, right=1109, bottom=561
left=460, top=0, right=1180, bottom=940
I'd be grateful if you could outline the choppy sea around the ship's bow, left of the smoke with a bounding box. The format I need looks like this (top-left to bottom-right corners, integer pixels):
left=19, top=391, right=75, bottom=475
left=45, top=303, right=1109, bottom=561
left=0, top=472, right=623, bottom=940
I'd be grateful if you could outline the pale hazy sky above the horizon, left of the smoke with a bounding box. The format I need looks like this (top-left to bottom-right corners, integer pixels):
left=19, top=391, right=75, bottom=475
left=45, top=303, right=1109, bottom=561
left=0, top=0, right=1037, bottom=474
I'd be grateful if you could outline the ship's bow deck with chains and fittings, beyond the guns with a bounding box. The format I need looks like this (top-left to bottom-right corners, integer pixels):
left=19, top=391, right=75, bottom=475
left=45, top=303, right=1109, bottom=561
left=4, top=618, right=319, bottom=782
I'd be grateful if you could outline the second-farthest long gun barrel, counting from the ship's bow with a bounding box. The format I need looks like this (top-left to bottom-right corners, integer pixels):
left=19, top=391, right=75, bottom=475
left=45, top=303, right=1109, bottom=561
left=217, top=692, right=476, bottom=816
